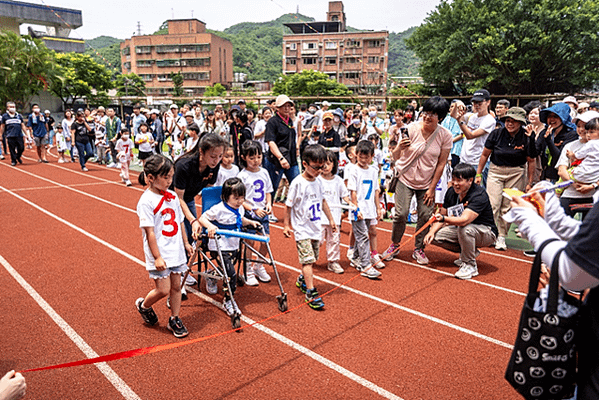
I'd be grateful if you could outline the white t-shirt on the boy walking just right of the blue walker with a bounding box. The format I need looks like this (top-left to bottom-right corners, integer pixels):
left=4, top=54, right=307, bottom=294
left=285, top=175, right=326, bottom=241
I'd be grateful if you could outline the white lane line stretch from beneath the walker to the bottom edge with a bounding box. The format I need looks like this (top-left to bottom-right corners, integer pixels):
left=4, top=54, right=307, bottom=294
left=187, top=286, right=403, bottom=400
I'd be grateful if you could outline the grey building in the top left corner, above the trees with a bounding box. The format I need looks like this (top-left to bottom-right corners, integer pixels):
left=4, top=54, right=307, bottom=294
left=0, top=0, right=85, bottom=53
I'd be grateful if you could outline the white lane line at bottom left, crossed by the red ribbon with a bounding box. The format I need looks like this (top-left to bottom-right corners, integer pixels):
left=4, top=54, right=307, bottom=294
left=0, top=256, right=141, bottom=400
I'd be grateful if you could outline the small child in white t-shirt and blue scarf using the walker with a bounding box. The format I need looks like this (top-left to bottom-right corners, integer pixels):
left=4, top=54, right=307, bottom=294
left=200, top=178, right=260, bottom=316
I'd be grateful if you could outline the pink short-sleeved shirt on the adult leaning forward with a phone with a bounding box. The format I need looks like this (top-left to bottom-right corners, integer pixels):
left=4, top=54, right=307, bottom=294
left=396, top=122, right=452, bottom=190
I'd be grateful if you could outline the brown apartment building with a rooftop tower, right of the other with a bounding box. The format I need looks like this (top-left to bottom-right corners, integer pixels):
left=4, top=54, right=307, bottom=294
left=283, top=1, right=389, bottom=94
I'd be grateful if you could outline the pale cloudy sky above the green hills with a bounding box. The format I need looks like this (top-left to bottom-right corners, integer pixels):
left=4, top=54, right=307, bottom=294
left=21, top=0, right=440, bottom=39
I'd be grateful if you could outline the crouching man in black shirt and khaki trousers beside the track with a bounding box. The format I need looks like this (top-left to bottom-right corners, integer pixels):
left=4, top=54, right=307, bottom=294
left=424, top=163, right=497, bottom=279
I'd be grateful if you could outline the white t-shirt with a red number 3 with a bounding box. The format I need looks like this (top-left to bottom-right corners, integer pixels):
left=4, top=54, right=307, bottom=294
left=137, top=189, right=187, bottom=271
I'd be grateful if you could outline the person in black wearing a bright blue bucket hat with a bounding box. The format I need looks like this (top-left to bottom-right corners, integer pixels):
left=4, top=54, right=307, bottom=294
left=536, top=103, right=578, bottom=182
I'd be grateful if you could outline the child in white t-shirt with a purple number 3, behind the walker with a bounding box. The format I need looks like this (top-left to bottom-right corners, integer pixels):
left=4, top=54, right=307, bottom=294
left=238, top=140, right=273, bottom=286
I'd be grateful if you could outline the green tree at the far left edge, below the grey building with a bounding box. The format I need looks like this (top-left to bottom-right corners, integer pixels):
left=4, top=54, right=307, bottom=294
left=0, top=30, right=54, bottom=109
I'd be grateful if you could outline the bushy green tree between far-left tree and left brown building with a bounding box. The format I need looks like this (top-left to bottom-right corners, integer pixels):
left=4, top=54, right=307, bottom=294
left=50, top=53, right=112, bottom=106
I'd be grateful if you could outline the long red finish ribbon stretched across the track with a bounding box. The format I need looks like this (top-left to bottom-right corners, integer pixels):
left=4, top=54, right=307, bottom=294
left=19, top=216, right=435, bottom=374
